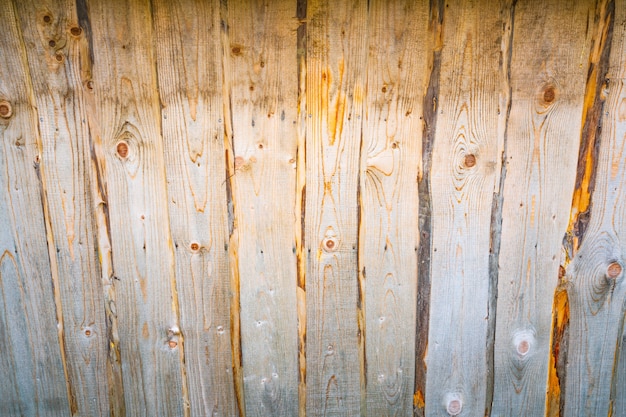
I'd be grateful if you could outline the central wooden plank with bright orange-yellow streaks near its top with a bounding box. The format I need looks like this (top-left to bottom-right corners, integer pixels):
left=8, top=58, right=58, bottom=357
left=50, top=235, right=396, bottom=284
left=305, top=1, right=367, bottom=416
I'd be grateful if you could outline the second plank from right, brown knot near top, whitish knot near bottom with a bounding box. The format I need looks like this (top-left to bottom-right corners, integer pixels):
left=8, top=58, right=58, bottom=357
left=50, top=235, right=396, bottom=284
left=492, top=0, right=595, bottom=416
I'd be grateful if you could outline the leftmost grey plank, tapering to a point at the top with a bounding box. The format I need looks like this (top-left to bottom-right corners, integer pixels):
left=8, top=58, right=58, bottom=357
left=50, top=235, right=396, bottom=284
left=0, top=2, right=70, bottom=416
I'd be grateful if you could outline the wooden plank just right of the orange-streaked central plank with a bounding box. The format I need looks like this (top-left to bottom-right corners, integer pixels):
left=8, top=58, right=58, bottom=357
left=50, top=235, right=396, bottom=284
left=359, top=0, right=429, bottom=416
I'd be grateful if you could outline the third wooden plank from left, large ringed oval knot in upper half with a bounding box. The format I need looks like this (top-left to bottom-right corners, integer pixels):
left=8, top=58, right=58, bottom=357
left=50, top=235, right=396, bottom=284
left=87, top=0, right=187, bottom=416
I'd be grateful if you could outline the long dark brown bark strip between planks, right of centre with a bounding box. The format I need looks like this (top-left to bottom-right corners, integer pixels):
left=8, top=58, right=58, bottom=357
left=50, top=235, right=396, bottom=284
left=413, top=0, right=445, bottom=417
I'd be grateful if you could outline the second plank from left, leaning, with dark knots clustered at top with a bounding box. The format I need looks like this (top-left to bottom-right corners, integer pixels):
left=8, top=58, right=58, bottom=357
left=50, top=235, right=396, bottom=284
left=15, top=1, right=110, bottom=415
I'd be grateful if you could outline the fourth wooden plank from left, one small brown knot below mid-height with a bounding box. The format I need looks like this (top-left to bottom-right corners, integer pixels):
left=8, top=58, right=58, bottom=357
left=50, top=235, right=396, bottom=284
left=152, top=0, right=237, bottom=416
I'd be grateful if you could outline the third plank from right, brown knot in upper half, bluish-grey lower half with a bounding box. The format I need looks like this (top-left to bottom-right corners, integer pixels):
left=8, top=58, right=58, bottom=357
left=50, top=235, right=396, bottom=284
left=425, top=1, right=504, bottom=416
